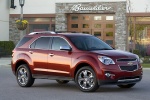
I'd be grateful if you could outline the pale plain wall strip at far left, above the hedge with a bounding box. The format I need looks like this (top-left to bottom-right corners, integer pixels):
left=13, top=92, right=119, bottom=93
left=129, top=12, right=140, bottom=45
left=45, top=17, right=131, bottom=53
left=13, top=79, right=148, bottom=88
left=0, top=0, right=9, bottom=41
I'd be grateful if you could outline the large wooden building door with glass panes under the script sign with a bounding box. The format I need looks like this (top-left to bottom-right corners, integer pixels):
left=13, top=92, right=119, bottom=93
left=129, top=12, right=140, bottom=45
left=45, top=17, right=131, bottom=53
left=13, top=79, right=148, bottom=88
left=68, top=14, right=115, bottom=47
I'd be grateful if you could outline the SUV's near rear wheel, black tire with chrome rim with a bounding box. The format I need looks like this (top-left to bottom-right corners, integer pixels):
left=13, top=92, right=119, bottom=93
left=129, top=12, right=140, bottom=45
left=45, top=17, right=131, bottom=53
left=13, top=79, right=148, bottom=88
left=16, top=64, right=35, bottom=87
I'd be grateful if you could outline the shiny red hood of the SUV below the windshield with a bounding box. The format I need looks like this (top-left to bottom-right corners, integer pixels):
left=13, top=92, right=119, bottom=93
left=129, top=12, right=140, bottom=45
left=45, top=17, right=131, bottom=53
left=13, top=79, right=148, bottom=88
left=92, top=50, right=136, bottom=58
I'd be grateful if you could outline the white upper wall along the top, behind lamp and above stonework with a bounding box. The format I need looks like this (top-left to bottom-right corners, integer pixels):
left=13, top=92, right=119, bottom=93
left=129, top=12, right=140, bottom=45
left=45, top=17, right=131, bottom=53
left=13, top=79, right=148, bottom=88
left=9, top=0, right=150, bottom=14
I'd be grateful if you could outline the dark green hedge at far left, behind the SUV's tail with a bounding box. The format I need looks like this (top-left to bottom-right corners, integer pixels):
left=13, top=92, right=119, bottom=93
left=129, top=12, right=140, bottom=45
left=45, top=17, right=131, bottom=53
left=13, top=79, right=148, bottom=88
left=0, top=41, right=15, bottom=57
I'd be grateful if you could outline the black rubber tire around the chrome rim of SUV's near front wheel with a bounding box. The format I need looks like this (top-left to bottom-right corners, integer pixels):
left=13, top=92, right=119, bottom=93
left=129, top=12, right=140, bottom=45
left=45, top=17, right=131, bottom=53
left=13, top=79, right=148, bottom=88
left=75, top=66, right=98, bottom=92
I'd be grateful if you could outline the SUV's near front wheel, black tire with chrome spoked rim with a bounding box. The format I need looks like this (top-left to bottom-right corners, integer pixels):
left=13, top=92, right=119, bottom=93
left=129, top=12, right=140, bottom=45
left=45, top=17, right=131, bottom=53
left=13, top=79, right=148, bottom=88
left=75, top=66, right=99, bottom=92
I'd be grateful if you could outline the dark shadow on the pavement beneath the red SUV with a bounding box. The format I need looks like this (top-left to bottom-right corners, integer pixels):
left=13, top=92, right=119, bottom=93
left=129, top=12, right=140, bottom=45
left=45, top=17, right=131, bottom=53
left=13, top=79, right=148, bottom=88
left=32, top=81, right=142, bottom=93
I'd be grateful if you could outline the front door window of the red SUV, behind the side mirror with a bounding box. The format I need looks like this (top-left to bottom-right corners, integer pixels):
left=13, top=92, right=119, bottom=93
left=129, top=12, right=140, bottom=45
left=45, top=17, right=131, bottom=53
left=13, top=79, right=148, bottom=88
left=52, top=37, right=69, bottom=50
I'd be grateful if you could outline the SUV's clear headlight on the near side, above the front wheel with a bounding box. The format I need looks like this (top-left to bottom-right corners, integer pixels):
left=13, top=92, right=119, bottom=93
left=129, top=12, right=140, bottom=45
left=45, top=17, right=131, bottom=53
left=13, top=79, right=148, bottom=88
left=98, top=56, right=115, bottom=65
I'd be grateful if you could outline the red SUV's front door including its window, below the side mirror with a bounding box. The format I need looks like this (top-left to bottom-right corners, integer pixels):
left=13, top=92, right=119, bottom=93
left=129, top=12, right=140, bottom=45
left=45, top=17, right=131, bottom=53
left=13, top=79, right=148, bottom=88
left=48, top=37, right=72, bottom=77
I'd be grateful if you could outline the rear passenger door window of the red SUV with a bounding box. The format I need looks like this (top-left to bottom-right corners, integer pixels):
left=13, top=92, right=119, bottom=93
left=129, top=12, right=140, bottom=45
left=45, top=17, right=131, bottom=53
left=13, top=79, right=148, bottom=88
left=30, top=37, right=50, bottom=49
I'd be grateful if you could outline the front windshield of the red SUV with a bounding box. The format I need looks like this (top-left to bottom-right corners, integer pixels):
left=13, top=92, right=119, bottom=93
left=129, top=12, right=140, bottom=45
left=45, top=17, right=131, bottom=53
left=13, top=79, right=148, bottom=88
left=69, top=36, right=113, bottom=51
